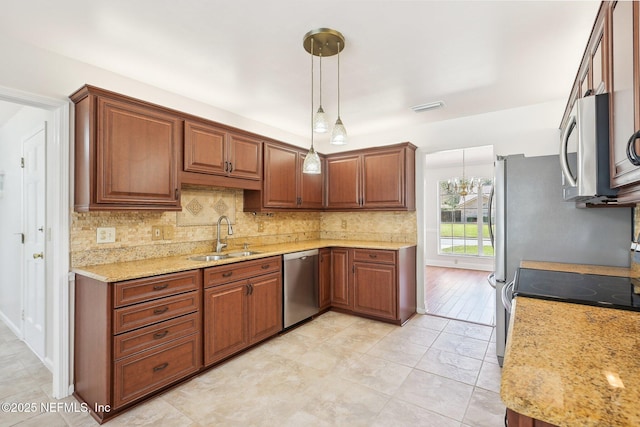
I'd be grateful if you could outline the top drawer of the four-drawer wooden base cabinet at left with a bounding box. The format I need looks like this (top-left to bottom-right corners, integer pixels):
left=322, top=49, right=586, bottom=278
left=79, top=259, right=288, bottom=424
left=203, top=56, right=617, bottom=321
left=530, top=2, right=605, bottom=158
left=113, top=270, right=200, bottom=307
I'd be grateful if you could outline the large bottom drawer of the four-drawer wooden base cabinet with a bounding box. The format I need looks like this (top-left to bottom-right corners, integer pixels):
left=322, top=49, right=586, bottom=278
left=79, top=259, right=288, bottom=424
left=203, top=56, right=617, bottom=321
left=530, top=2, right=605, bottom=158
left=113, top=334, right=201, bottom=408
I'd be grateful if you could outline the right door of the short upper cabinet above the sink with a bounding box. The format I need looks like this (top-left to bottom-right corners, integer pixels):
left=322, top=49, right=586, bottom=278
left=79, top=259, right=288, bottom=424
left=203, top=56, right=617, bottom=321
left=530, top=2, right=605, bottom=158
left=227, top=133, right=262, bottom=181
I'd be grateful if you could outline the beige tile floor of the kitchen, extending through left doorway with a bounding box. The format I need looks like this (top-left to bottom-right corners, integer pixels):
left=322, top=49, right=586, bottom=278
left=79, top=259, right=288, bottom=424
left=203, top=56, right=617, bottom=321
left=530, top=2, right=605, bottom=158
left=0, top=312, right=505, bottom=427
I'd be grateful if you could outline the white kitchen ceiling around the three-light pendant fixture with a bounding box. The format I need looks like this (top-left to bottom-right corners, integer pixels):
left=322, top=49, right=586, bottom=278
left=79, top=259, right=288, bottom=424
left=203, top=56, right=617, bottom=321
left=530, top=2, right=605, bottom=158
left=0, top=0, right=600, bottom=142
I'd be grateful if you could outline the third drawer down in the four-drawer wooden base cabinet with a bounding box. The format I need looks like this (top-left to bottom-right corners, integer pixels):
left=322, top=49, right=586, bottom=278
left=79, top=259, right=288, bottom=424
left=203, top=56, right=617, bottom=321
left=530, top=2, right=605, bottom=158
left=113, top=313, right=200, bottom=360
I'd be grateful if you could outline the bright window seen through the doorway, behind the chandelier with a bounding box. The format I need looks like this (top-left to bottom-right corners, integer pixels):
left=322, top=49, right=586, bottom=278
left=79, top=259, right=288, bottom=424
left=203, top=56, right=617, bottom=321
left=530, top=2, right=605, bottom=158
left=438, top=178, right=493, bottom=257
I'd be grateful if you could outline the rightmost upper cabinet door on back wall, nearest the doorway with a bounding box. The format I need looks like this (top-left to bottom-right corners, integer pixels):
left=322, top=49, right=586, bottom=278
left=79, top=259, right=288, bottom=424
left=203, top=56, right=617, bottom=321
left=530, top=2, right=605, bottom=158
left=362, top=149, right=405, bottom=208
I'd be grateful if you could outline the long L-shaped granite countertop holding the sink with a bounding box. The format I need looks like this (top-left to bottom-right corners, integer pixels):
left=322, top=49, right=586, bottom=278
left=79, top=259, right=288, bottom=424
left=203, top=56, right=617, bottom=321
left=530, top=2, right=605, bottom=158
left=71, top=240, right=415, bottom=282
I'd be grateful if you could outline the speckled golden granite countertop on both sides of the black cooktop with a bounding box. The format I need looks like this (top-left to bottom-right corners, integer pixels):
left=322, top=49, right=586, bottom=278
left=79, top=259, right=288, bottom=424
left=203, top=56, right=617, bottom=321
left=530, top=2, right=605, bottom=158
left=500, top=262, right=640, bottom=427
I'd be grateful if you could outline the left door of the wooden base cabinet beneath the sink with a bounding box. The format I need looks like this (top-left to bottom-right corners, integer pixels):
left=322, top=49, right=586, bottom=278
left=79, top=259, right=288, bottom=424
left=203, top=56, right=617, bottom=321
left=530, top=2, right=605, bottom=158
left=204, top=282, right=249, bottom=365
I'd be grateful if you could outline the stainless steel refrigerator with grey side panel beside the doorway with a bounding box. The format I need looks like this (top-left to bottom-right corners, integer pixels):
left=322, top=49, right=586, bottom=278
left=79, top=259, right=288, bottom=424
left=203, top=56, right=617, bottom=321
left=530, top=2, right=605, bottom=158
left=493, top=155, right=633, bottom=365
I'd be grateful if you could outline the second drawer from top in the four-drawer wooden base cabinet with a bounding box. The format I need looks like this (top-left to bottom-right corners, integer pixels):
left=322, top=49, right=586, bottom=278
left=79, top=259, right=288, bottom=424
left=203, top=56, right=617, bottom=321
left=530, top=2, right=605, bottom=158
left=113, top=291, right=200, bottom=334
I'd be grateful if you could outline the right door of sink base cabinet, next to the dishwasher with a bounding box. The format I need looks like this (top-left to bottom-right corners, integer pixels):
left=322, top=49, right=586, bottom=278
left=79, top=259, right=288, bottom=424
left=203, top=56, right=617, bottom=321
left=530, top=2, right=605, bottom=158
left=248, top=273, right=282, bottom=343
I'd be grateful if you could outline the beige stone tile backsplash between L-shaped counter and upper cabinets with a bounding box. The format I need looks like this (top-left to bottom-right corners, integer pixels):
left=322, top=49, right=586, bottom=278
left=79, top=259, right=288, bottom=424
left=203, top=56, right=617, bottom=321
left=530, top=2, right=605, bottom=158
left=70, top=187, right=417, bottom=267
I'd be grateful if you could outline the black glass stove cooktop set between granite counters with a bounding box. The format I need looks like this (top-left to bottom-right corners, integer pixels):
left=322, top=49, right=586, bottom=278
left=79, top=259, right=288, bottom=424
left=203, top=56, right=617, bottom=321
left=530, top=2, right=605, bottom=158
left=513, top=268, right=640, bottom=311
